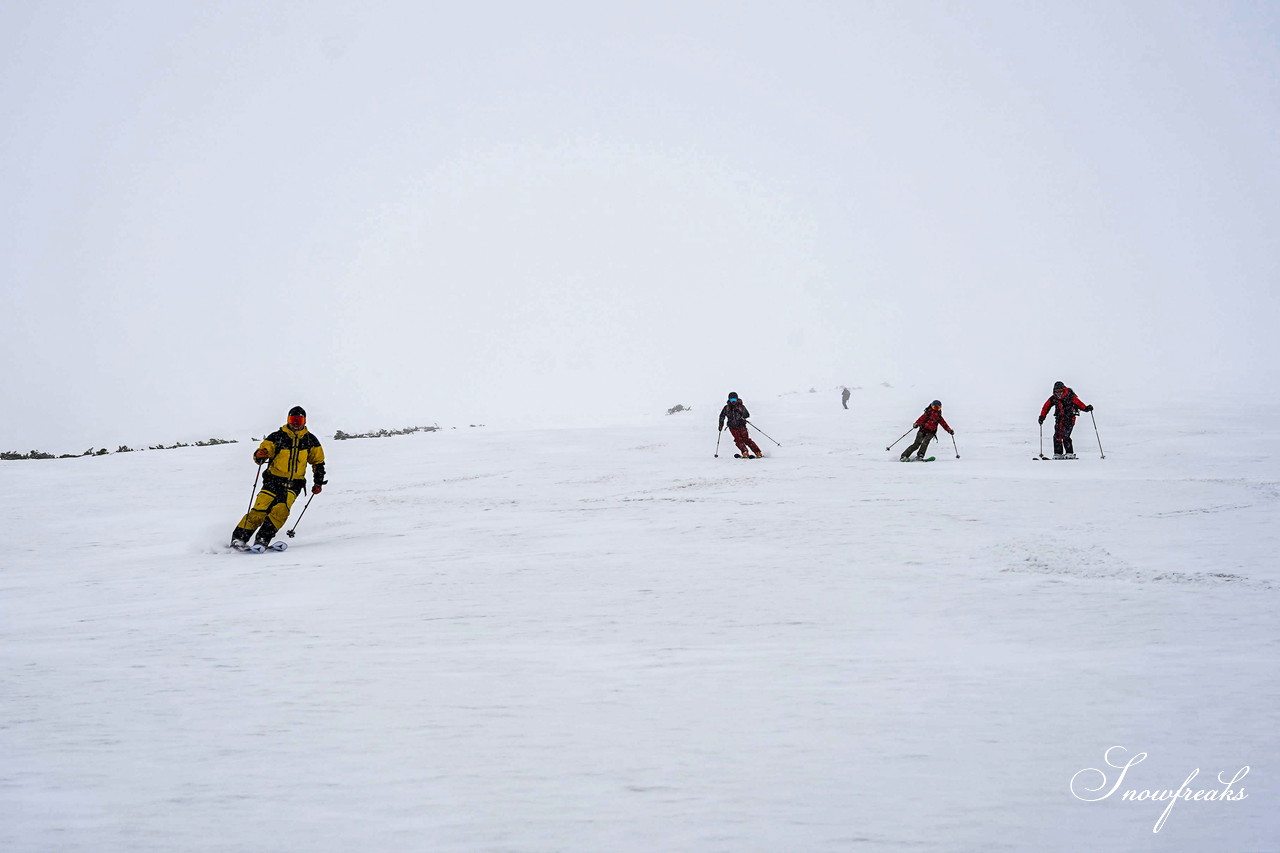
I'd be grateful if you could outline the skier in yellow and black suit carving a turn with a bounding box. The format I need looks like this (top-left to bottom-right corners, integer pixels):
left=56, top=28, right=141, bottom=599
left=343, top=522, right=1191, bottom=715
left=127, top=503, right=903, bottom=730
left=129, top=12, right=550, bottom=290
left=232, top=406, right=328, bottom=549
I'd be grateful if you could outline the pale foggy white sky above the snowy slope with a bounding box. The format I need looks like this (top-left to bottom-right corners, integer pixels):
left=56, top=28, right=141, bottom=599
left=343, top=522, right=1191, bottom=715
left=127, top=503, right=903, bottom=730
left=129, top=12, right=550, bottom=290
left=0, top=0, right=1280, bottom=452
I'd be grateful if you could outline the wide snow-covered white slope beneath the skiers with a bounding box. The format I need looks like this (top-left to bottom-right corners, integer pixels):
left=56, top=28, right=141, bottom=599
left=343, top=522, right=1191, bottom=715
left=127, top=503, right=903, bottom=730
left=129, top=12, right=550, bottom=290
left=0, top=388, right=1280, bottom=853
